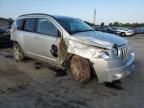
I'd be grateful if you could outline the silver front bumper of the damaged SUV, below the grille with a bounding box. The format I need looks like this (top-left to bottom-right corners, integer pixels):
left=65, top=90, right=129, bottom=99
left=91, top=53, right=135, bottom=83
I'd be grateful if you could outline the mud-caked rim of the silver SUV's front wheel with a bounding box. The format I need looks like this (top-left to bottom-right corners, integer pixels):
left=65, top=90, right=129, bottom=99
left=70, top=57, right=82, bottom=81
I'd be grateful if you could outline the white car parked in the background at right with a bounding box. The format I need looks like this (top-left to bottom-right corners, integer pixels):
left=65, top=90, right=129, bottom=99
left=115, top=27, right=134, bottom=37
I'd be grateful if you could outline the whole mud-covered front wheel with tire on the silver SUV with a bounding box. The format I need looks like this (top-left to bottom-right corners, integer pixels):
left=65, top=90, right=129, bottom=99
left=69, top=55, right=91, bottom=83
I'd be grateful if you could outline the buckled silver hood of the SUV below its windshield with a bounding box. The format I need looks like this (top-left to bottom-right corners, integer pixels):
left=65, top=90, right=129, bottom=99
left=71, top=31, right=128, bottom=49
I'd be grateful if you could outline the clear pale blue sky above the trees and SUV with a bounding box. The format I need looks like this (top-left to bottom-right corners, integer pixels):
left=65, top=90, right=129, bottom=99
left=0, top=0, right=144, bottom=24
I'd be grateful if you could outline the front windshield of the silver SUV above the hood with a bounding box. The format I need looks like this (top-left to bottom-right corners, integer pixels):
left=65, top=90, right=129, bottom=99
left=56, top=18, right=94, bottom=34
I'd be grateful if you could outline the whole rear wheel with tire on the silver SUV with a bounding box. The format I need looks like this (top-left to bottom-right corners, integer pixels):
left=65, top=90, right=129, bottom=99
left=12, top=43, right=24, bottom=61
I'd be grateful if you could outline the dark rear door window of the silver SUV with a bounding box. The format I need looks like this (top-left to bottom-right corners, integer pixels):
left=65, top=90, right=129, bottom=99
left=24, top=19, right=35, bottom=32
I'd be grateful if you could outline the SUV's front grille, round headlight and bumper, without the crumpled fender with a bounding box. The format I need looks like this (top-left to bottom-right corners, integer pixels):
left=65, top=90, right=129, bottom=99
left=90, top=45, right=135, bottom=83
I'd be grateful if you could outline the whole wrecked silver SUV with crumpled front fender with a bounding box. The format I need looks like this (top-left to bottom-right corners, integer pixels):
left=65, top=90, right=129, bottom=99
left=11, top=14, right=135, bottom=83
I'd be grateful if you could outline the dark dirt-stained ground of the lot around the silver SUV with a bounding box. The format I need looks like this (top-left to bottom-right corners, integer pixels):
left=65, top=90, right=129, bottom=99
left=0, top=35, right=144, bottom=108
